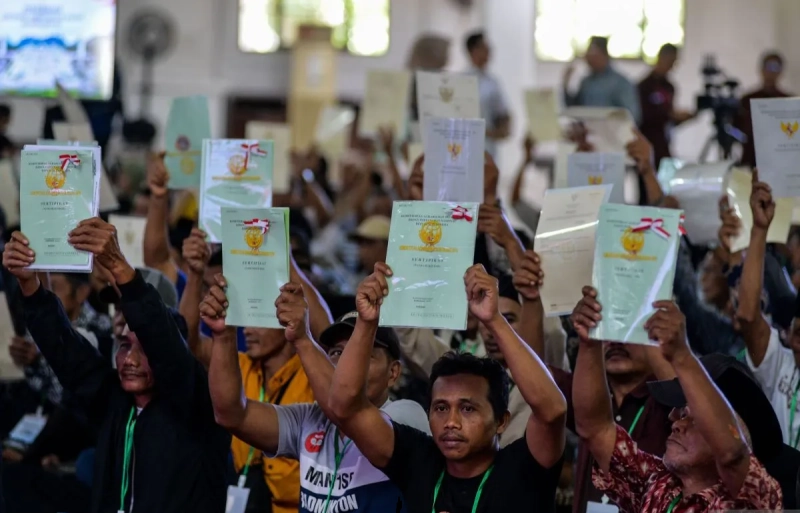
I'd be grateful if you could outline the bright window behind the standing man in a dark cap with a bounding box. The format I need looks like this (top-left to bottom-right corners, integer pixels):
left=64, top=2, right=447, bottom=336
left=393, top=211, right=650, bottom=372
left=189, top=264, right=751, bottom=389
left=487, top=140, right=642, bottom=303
left=536, top=0, right=684, bottom=62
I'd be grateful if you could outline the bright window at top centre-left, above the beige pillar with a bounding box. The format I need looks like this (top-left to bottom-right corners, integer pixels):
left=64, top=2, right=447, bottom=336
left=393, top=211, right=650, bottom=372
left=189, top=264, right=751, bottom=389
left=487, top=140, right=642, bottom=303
left=239, top=0, right=389, bottom=56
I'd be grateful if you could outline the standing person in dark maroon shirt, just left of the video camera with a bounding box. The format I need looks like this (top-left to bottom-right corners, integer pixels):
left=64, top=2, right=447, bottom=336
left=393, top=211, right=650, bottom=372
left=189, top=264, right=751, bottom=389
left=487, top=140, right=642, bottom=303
left=638, top=43, right=696, bottom=169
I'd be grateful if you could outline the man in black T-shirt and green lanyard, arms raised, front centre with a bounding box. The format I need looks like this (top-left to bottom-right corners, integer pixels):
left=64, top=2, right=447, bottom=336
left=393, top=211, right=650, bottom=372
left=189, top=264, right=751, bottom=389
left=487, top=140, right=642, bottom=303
left=329, top=264, right=566, bottom=513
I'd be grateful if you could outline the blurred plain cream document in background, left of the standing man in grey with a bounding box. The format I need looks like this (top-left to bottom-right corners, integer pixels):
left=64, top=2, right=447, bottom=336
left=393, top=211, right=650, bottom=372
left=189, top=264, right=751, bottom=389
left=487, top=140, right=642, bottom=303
left=358, top=69, right=411, bottom=137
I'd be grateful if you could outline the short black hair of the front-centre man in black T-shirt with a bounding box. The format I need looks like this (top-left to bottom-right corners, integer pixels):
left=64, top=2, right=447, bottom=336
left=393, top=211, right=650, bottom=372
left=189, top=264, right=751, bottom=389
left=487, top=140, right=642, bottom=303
left=430, top=351, right=509, bottom=420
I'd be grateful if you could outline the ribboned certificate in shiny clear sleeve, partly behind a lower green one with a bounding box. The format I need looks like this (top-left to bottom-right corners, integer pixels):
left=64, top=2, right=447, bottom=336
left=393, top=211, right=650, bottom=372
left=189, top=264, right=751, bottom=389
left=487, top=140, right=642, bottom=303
left=199, top=139, right=275, bottom=242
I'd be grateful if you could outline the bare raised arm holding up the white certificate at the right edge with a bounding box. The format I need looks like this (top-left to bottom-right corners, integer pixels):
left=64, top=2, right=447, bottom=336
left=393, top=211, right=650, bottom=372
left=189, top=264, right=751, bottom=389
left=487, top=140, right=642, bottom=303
left=736, top=170, right=775, bottom=367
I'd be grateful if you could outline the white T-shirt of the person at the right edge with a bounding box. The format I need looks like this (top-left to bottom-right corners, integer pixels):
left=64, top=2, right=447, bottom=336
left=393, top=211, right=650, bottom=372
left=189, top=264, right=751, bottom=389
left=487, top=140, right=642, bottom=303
left=745, top=329, right=800, bottom=447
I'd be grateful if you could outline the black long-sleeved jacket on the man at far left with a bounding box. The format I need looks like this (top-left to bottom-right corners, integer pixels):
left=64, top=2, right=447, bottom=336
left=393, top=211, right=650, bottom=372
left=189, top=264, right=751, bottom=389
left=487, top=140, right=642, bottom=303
left=24, top=273, right=231, bottom=513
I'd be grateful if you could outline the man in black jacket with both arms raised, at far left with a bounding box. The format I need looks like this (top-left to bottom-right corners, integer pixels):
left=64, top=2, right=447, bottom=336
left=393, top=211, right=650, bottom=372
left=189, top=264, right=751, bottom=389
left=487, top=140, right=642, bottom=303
left=3, top=218, right=230, bottom=513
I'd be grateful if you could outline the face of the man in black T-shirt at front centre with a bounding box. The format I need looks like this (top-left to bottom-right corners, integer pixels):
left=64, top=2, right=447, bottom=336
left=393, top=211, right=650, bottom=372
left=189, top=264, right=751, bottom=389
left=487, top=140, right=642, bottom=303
left=429, top=374, right=507, bottom=461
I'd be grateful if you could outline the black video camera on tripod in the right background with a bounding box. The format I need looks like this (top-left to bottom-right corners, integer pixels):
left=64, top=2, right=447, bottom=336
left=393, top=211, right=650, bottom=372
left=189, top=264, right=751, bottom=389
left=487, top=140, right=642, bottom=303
left=697, top=55, right=747, bottom=162
